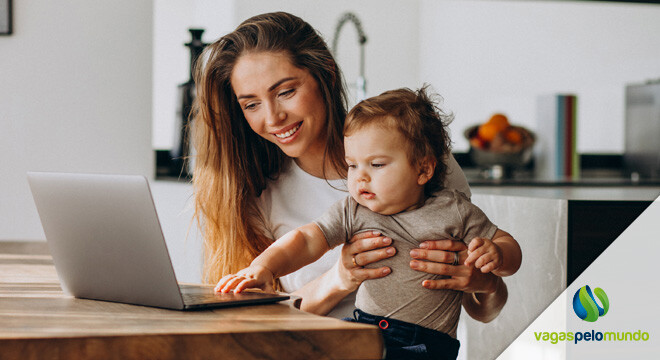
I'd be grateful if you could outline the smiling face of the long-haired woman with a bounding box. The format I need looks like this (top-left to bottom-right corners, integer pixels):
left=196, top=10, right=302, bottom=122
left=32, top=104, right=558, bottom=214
left=230, top=52, right=326, bottom=163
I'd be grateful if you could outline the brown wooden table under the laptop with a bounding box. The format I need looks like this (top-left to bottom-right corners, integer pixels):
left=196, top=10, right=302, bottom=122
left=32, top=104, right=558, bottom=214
left=0, top=242, right=383, bottom=360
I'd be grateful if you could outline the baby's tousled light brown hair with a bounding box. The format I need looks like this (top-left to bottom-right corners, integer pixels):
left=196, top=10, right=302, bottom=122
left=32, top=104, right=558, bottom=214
left=344, top=85, right=454, bottom=196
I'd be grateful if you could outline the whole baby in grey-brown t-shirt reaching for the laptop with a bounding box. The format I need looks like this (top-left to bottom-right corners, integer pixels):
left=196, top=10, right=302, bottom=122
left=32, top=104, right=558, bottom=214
left=216, top=88, right=522, bottom=358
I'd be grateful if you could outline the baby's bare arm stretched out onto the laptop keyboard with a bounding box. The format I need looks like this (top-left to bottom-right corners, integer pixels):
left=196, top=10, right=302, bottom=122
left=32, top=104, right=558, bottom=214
left=215, top=223, right=330, bottom=293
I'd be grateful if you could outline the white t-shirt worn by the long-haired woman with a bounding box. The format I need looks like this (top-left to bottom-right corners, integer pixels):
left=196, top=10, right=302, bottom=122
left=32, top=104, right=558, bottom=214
left=259, top=156, right=471, bottom=318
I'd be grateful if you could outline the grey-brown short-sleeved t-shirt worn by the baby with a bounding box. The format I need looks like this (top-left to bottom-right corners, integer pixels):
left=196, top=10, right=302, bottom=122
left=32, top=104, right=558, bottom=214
left=315, top=190, right=497, bottom=337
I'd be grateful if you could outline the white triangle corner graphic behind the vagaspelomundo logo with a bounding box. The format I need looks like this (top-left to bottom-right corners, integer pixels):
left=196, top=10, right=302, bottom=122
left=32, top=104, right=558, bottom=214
left=498, top=198, right=660, bottom=360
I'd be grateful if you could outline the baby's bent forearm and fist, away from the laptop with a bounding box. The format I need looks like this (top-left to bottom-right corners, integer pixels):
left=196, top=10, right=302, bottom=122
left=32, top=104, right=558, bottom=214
left=465, top=229, right=522, bottom=276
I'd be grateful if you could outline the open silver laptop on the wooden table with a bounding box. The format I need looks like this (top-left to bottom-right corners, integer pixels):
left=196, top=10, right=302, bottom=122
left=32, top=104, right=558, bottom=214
left=28, top=172, right=289, bottom=310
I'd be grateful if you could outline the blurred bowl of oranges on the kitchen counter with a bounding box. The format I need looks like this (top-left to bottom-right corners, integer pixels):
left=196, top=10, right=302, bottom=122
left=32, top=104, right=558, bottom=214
left=465, top=113, right=536, bottom=168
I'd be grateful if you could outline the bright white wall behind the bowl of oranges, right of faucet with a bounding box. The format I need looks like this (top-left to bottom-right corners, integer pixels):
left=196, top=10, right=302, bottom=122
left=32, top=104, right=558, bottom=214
left=419, top=0, right=660, bottom=153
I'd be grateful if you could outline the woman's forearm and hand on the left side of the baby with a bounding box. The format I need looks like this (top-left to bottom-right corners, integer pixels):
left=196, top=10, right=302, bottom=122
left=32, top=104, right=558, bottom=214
left=293, top=231, right=396, bottom=315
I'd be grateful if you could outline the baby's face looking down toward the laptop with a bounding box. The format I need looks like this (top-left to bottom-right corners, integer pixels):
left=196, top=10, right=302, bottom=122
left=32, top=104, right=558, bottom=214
left=344, top=125, right=424, bottom=215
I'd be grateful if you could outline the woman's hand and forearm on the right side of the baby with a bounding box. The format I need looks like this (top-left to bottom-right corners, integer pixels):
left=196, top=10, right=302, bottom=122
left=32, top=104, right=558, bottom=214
left=410, top=240, right=498, bottom=293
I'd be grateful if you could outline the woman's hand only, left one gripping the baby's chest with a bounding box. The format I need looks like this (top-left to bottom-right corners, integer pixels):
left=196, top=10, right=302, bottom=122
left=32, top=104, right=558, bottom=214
left=339, top=231, right=396, bottom=291
